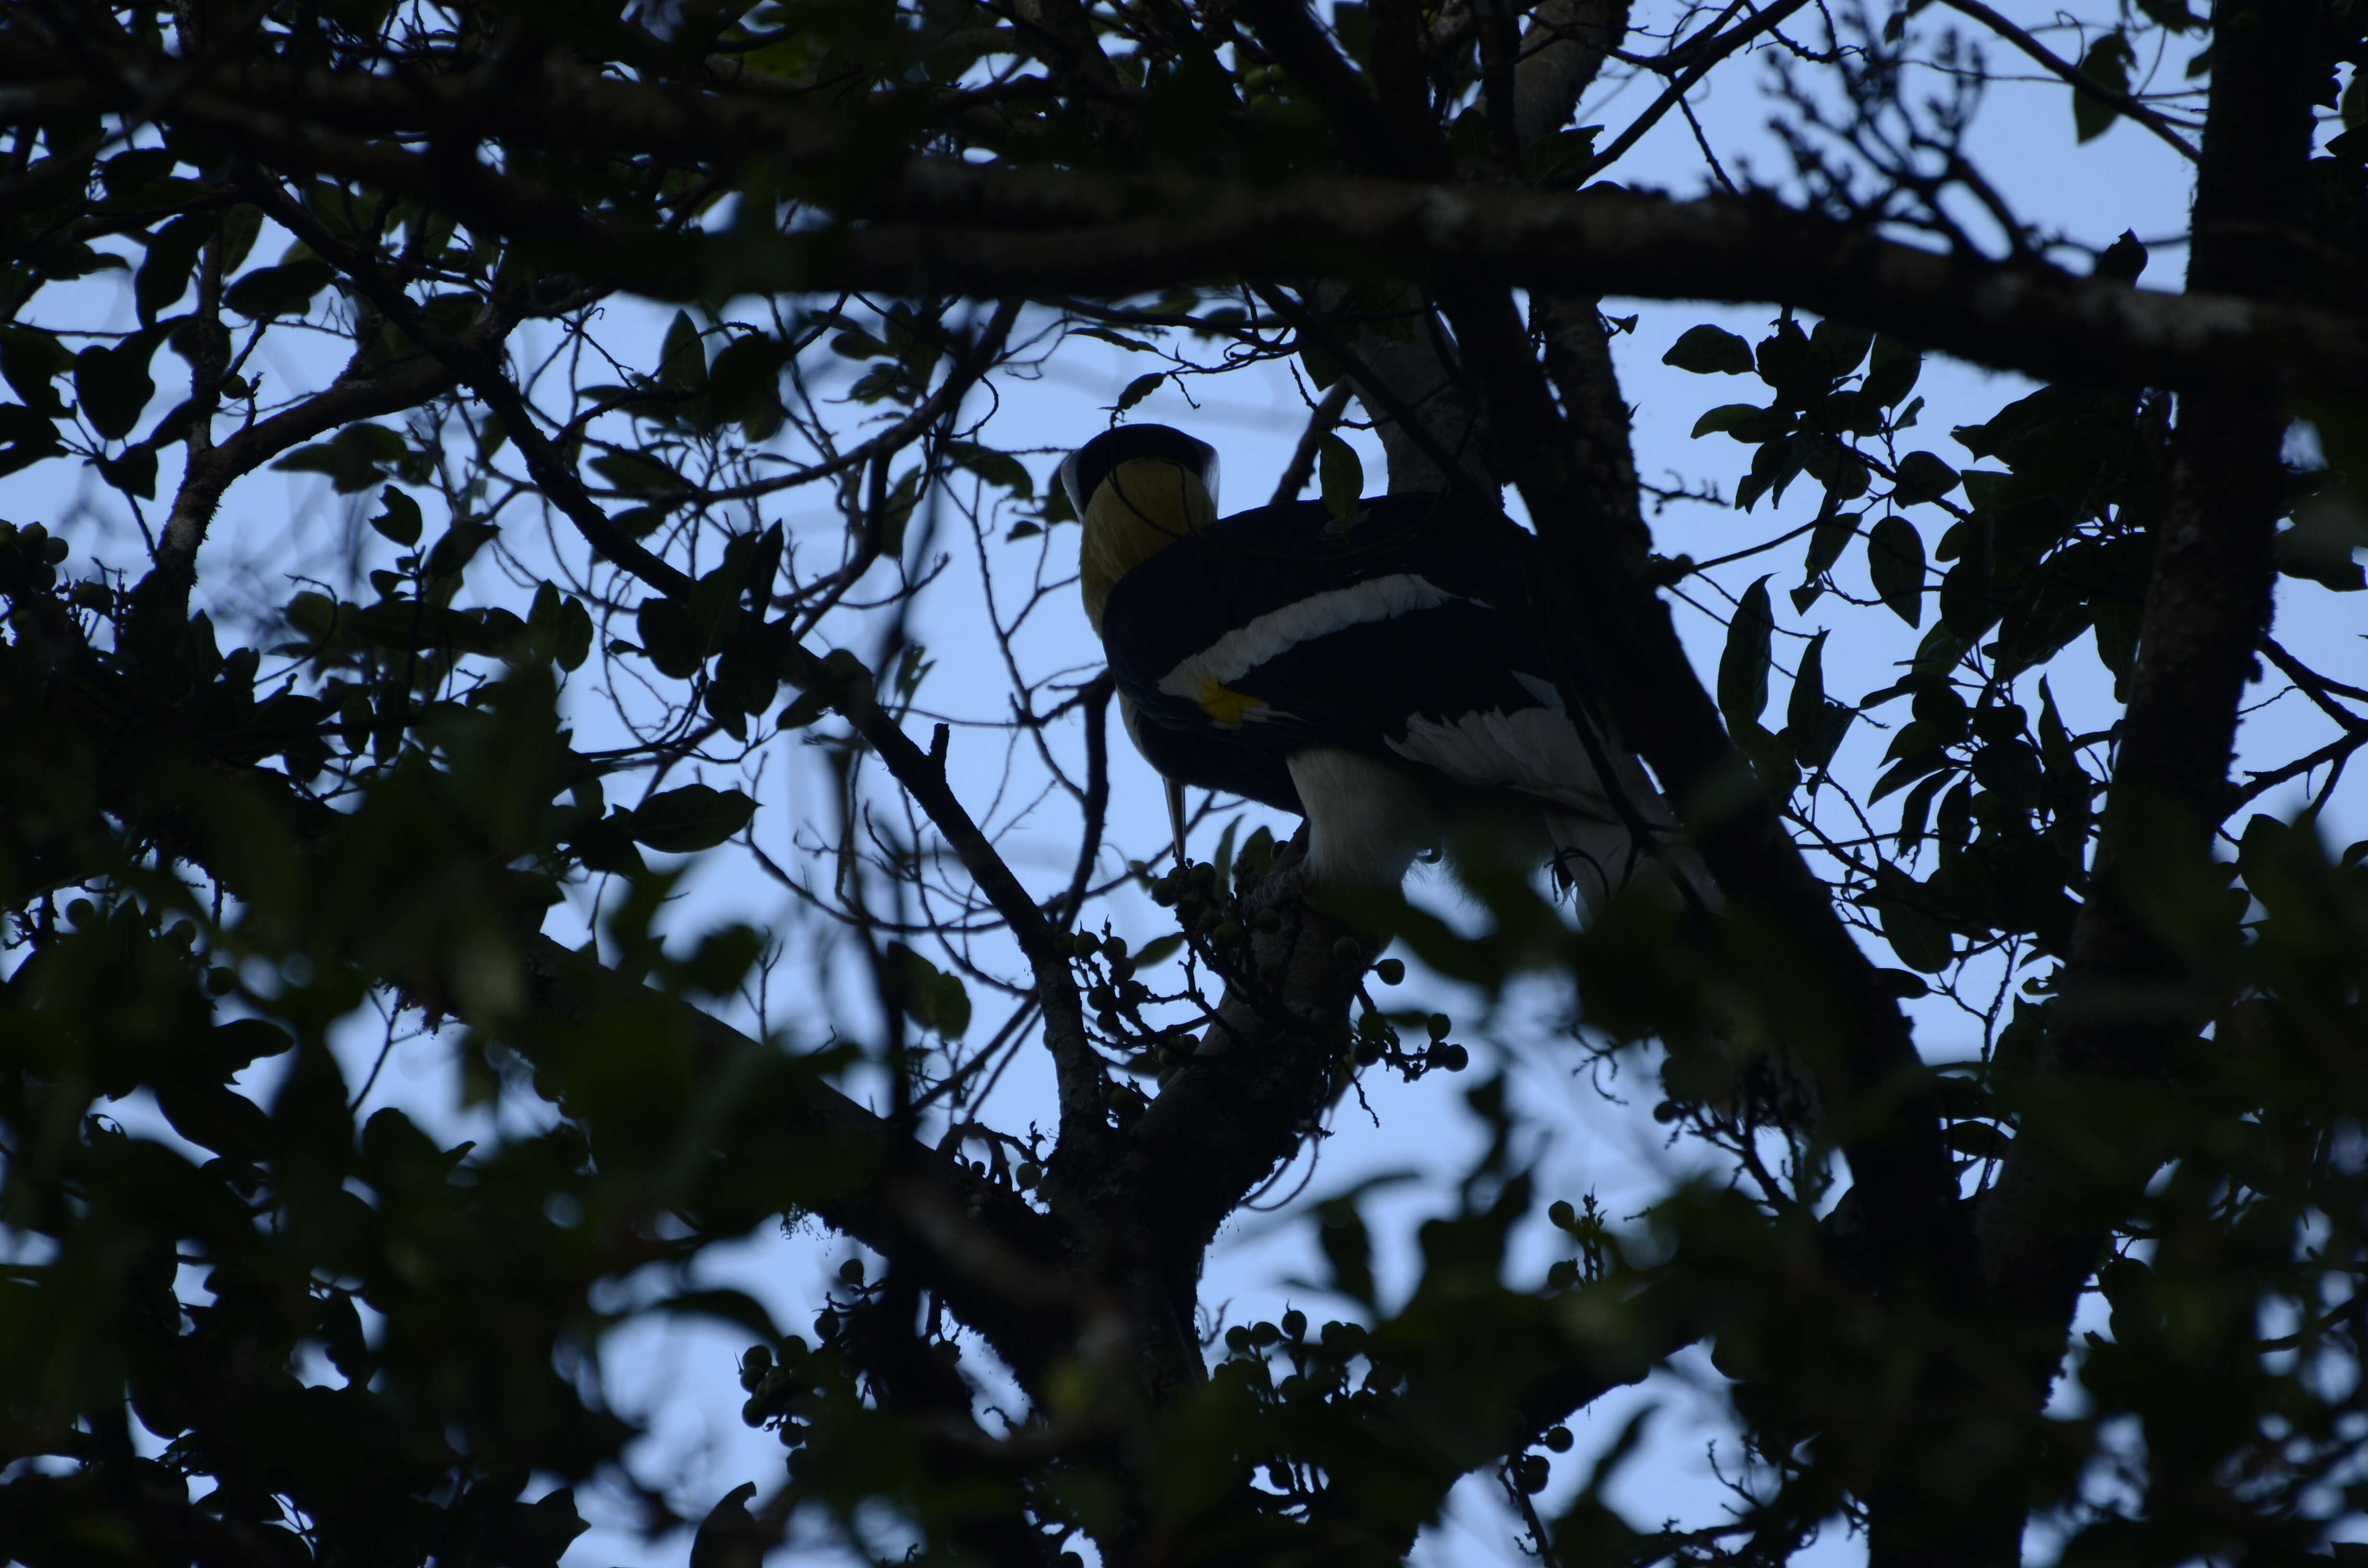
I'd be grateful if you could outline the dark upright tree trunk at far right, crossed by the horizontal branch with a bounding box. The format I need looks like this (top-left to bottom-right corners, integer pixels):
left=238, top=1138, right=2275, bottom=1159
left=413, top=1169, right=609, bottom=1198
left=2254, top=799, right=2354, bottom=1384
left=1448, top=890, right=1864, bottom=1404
left=1977, top=0, right=2328, bottom=1561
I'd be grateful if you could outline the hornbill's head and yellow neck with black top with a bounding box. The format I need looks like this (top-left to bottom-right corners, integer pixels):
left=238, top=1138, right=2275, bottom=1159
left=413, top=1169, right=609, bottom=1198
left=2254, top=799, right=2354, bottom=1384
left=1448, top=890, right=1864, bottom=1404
left=1061, top=424, right=1217, bottom=632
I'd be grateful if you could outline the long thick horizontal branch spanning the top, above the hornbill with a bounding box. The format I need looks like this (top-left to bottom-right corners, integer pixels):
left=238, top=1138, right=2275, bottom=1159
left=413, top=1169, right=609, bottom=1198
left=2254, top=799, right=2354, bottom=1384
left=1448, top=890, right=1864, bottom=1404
left=19, top=40, right=2368, bottom=395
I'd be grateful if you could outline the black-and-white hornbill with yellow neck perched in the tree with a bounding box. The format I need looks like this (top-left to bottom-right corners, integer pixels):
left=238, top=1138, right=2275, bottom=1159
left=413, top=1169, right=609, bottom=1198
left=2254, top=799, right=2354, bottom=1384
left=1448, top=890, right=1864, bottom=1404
left=1061, top=424, right=1714, bottom=909
